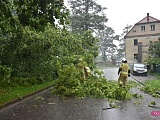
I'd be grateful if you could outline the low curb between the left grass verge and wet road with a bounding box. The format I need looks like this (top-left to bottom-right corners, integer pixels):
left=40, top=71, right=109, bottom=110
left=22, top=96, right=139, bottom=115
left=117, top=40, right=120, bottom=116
left=0, top=85, right=53, bottom=110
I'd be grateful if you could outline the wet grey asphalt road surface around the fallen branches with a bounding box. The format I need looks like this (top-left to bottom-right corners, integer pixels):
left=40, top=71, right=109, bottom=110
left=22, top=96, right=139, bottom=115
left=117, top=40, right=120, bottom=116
left=0, top=68, right=160, bottom=120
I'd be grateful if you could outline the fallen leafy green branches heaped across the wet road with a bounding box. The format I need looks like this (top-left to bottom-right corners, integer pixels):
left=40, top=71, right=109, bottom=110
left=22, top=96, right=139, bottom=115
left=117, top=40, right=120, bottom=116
left=52, top=64, right=133, bottom=100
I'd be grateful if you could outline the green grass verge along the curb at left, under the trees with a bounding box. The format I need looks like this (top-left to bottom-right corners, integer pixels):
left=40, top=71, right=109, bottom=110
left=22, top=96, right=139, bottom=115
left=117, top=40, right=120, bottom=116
left=0, top=81, right=54, bottom=106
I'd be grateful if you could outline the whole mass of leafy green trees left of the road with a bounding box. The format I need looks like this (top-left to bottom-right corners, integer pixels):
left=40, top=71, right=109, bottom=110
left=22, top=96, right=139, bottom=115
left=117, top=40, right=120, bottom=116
left=0, top=0, right=98, bottom=86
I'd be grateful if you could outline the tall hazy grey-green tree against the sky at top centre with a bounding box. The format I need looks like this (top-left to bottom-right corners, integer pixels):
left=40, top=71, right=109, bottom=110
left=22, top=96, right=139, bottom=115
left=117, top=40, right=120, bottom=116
left=68, top=0, right=108, bottom=33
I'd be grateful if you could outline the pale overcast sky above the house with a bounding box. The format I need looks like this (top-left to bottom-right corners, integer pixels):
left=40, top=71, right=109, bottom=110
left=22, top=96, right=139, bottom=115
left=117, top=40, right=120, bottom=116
left=96, top=0, right=160, bottom=35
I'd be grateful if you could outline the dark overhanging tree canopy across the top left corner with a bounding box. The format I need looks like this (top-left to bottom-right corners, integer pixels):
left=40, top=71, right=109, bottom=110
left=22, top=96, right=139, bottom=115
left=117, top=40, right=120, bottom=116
left=0, top=0, right=69, bottom=31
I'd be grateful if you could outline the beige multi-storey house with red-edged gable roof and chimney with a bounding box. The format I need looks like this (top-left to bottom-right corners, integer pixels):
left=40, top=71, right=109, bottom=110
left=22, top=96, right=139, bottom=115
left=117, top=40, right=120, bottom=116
left=124, top=13, right=160, bottom=63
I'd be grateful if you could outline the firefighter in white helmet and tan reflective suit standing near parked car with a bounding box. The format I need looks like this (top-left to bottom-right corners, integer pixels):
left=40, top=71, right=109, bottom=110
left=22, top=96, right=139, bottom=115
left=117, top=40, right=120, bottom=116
left=118, top=58, right=130, bottom=87
